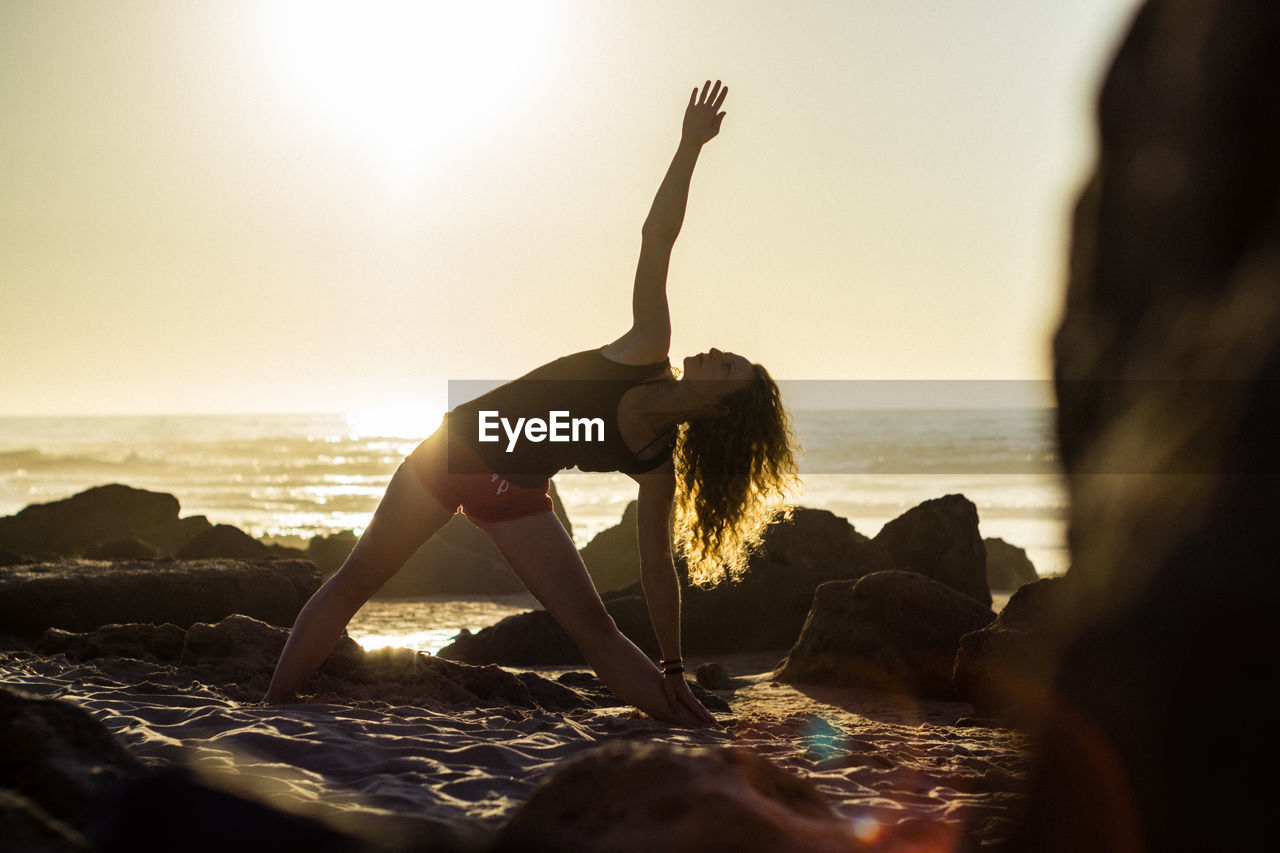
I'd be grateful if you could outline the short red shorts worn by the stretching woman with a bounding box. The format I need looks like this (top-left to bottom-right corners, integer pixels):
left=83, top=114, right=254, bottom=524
left=406, top=419, right=552, bottom=521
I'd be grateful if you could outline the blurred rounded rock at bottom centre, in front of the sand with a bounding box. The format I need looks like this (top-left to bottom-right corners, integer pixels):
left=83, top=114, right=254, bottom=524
left=495, top=742, right=859, bottom=853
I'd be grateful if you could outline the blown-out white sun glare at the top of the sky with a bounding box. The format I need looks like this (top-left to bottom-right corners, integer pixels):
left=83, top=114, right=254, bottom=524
left=261, top=0, right=557, bottom=173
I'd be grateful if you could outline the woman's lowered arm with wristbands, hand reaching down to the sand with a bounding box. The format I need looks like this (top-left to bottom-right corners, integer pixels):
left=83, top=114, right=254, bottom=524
left=632, top=462, right=716, bottom=725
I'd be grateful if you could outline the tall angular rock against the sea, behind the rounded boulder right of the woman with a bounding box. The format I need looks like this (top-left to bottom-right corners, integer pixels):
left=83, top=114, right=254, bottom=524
left=873, top=494, right=991, bottom=606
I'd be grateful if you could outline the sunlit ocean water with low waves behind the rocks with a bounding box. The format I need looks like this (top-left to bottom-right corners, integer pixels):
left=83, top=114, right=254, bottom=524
left=0, top=407, right=1069, bottom=651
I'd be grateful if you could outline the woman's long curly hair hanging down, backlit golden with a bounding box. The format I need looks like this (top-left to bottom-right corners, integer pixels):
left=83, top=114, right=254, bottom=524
left=675, top=364, right=799, bottom=587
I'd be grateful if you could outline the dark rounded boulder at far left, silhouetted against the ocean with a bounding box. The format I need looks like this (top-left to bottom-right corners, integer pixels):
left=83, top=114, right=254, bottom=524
left=0, top=483, right=210, bottom=558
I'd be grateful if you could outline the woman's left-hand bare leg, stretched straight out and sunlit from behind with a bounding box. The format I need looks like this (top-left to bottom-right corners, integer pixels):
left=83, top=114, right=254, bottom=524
left=262, top=465, right=454, bottom=702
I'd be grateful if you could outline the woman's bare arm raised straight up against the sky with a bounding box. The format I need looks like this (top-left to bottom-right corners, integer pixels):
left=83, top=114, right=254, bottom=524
left=609, top=81, right=728, bottom=364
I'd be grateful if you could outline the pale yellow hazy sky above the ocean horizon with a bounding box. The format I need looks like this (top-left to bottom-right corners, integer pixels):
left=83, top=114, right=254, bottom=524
left=0, top=0, right=1135, bottom=415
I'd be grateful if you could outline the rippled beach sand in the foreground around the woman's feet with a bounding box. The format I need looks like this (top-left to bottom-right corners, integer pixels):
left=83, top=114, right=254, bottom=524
left=0, top=651, right=1028, bottom=841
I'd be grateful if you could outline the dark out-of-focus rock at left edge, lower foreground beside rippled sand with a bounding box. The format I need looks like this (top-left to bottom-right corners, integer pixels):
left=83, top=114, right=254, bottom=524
left=0, top=685, right=142, bottom=840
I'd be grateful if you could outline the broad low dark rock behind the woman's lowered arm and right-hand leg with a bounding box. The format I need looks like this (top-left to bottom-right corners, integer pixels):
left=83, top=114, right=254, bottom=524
left=440, top=508, right=892, bottom=666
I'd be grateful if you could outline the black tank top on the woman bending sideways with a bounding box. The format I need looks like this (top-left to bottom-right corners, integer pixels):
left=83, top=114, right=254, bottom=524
left=448, top=347, right=675, bottom=488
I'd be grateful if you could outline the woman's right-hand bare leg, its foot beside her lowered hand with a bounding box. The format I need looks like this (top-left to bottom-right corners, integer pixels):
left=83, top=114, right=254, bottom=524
left=476, top=512, right=705, bottom=726
